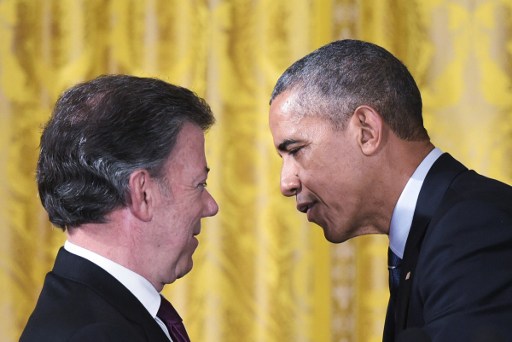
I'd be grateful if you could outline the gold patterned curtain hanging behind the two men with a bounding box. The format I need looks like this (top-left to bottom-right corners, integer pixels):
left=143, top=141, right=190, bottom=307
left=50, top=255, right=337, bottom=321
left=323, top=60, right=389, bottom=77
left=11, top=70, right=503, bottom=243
left=0, top=0, right=512, bottom=342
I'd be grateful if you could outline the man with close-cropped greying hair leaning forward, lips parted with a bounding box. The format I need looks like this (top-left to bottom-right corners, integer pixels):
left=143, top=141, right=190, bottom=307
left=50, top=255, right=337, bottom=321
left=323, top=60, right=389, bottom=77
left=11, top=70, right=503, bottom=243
left=269, top=40, right=512, bottom=342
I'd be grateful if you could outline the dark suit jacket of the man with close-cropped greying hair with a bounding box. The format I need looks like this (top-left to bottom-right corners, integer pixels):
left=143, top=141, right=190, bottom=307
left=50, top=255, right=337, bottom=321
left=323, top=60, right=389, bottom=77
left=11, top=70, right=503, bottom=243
left=395, top=153, right=512, bottom=342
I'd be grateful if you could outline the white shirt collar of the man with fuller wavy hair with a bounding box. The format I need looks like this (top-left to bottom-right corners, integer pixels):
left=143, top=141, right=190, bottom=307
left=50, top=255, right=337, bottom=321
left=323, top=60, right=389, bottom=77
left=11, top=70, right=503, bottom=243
left=64, top=241, right=172, bottom=342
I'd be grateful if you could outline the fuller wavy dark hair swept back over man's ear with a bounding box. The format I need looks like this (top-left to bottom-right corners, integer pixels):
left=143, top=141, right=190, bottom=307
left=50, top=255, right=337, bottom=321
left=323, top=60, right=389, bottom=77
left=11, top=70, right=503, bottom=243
left=37, top=75, right=215, bottom=230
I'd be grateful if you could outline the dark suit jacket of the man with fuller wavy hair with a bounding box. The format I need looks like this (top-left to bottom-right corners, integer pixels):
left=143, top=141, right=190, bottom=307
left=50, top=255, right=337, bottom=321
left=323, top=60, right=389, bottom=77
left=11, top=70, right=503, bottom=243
left=20, top=248, right=169, bottom=342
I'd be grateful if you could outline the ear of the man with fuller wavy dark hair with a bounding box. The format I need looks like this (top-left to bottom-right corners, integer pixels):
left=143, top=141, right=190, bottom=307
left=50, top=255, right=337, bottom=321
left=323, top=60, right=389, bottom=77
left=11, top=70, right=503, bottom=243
left=128, top=170, right=153, bottom=222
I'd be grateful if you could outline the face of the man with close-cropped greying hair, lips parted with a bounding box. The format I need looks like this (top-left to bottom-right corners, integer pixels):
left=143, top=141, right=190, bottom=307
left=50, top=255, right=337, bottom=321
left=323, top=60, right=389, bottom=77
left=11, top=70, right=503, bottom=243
left=269, top=92, right=376, bottom=242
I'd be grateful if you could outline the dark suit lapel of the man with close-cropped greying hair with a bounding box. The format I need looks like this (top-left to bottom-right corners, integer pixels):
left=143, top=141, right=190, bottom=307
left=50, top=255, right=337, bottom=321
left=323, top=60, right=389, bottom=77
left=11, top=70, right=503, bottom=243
left=395, top=153, right=467, bottom=333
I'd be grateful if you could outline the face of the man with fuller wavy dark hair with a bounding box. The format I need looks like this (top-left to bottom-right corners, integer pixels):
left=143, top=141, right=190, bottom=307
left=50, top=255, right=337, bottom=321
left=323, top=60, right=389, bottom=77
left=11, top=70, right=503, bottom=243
left=143, top=123, right=218, bottom=286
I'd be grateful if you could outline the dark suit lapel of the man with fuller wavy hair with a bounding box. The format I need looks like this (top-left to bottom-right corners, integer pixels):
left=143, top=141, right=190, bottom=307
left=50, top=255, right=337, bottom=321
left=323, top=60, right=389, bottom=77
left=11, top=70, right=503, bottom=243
left=53, top=248, right=168, bottom=341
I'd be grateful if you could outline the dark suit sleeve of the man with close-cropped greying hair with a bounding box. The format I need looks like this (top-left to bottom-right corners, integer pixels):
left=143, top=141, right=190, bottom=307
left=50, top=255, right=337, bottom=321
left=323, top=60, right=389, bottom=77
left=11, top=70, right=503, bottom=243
left=417, top=198, right=512, bottom=342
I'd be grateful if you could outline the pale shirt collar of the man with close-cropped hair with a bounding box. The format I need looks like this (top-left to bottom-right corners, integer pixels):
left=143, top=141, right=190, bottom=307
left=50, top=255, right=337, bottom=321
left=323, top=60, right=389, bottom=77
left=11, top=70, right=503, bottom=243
left=389, top=148, right=443, bottom=259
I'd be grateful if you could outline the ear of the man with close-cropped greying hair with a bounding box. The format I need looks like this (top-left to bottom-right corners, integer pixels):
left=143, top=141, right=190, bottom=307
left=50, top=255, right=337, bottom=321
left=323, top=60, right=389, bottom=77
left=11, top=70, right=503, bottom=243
left=352, top=106, right=384, bottom=156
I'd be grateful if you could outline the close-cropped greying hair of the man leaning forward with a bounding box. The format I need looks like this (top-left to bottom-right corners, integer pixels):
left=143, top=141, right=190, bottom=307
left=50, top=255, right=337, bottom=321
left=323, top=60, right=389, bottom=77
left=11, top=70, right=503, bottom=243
left=270, top=39, right=429, bottom=140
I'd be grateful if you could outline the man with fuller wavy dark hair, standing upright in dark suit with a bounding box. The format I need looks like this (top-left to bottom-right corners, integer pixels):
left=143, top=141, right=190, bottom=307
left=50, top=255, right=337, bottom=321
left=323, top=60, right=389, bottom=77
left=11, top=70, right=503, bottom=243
left=21, top=75, right=218, bottom=342
